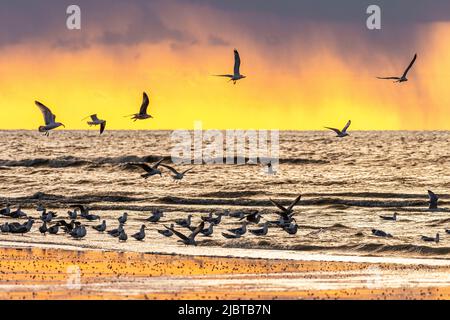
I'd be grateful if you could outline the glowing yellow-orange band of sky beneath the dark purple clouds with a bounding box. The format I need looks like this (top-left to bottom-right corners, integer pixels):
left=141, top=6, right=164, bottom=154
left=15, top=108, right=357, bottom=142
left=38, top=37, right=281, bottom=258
left=0, top=3, right=450, bottom=130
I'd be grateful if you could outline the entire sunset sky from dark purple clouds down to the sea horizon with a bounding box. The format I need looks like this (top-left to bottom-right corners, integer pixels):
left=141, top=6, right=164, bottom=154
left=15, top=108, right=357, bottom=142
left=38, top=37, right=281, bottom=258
left=0, top=0, right=450, bottom=130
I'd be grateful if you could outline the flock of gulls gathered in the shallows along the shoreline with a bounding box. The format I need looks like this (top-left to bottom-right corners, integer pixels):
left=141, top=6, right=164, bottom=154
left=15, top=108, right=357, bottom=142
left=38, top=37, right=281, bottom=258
left=0, top=190, right=450, bottom=245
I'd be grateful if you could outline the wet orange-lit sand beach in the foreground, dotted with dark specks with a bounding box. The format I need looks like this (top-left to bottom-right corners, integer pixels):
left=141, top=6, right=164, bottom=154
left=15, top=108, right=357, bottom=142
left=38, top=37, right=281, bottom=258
left=0, top=247, right=450, bottom=299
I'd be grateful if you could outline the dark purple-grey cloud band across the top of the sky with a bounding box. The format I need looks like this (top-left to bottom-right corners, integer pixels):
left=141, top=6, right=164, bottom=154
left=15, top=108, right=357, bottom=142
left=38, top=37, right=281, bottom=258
left=0, top=0, right=450, bottom=50
